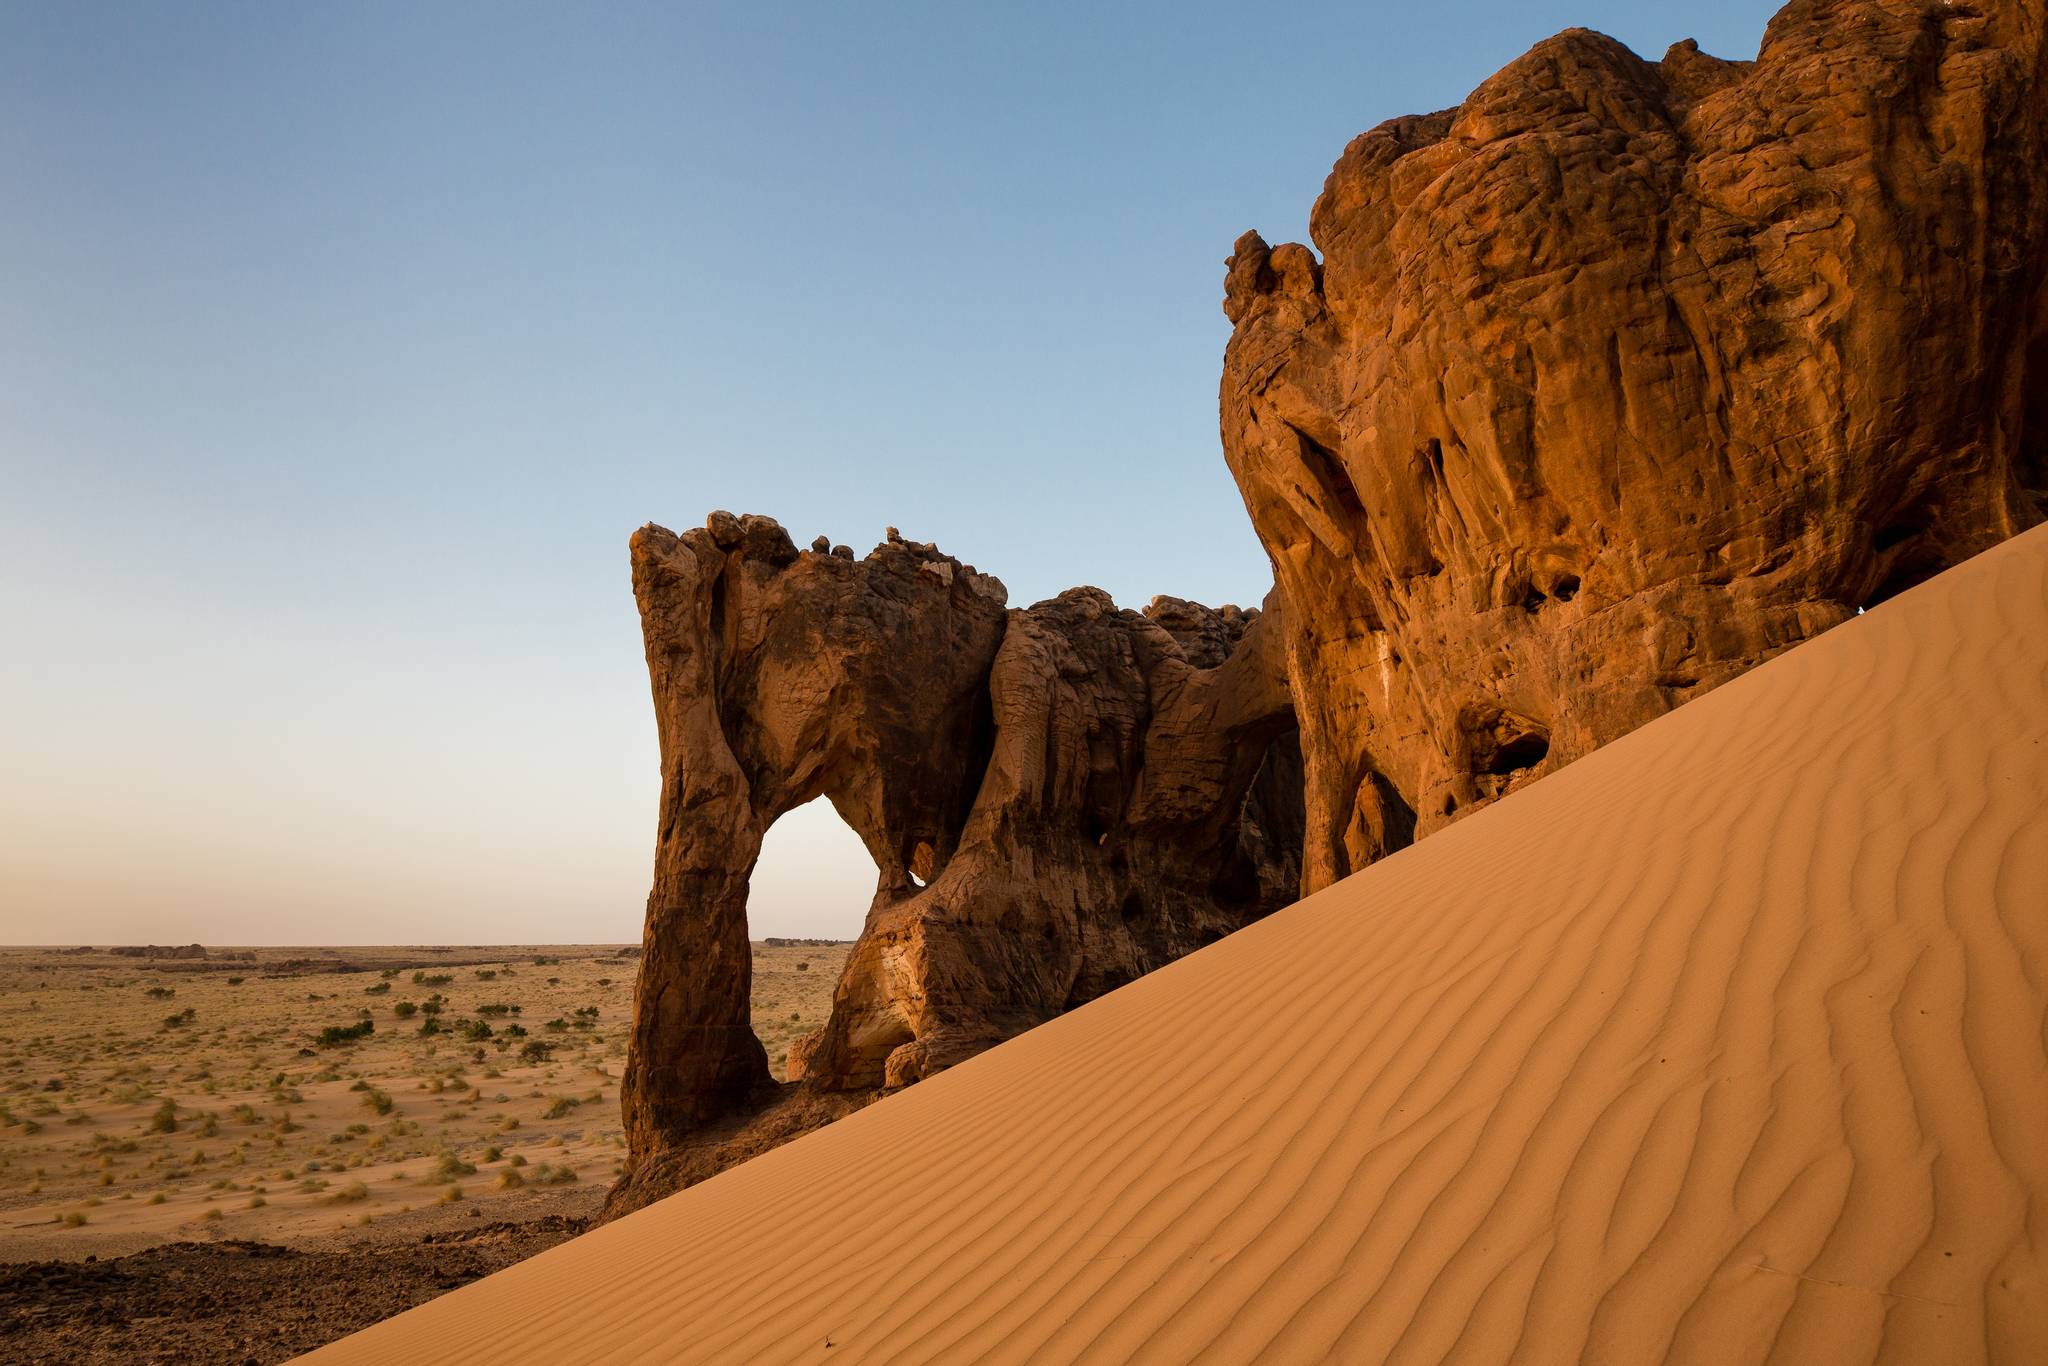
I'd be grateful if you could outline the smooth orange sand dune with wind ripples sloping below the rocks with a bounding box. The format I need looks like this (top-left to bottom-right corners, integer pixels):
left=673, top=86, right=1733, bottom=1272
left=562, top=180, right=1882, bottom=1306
left=309, top=528, right=2048, bottom=1366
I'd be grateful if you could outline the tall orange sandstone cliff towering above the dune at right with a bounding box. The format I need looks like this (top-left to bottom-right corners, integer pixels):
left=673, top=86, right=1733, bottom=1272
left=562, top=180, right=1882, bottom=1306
left=1221, top=0, right=2048, bottom=891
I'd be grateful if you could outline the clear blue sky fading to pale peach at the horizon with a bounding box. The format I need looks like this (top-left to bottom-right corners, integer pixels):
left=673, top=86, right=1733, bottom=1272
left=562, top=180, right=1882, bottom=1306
left=0, top=0, right=1774, bottom=942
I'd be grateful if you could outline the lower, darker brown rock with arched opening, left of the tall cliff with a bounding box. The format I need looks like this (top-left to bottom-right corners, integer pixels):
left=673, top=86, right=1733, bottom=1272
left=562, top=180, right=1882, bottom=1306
left=625, top=512, right=1300, bottom=1161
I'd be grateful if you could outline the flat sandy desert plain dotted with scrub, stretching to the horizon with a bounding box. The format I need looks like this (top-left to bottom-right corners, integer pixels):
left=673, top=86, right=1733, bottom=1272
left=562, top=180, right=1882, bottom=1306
left=0, top=942, right=848, bottom=1362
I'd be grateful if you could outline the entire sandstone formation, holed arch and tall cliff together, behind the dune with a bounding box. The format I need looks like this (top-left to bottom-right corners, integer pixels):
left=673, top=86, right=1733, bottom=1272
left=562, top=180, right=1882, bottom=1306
left=614, top=0, right=2048, bottom=1208
